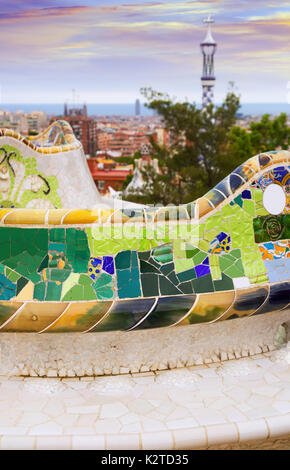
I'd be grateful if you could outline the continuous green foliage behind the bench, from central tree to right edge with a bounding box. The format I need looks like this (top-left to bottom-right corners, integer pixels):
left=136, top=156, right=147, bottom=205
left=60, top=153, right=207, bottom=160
left=124, top=87, right=290, bottom=205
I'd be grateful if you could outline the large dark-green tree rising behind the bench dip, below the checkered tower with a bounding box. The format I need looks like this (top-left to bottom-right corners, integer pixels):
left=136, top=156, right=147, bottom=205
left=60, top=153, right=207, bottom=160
left=125, top=88, right=240, bottom=204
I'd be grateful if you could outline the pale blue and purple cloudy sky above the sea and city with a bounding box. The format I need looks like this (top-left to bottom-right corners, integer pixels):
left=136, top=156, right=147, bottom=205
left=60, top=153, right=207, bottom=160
left=0, top=0, right=290, bottom=103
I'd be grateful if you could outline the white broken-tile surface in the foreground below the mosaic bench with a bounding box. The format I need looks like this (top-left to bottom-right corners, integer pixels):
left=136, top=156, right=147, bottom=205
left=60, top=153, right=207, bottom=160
left=0, top=343, right=290, bottom=449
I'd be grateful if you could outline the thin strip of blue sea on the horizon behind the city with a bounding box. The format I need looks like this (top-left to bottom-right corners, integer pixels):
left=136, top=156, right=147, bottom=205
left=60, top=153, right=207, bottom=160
left=0, top=102, right=290, bottom=116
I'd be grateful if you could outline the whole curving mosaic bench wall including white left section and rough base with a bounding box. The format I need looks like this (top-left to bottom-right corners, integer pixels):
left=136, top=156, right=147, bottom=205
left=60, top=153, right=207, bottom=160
left=0, top=121, right=290, bottom=375
